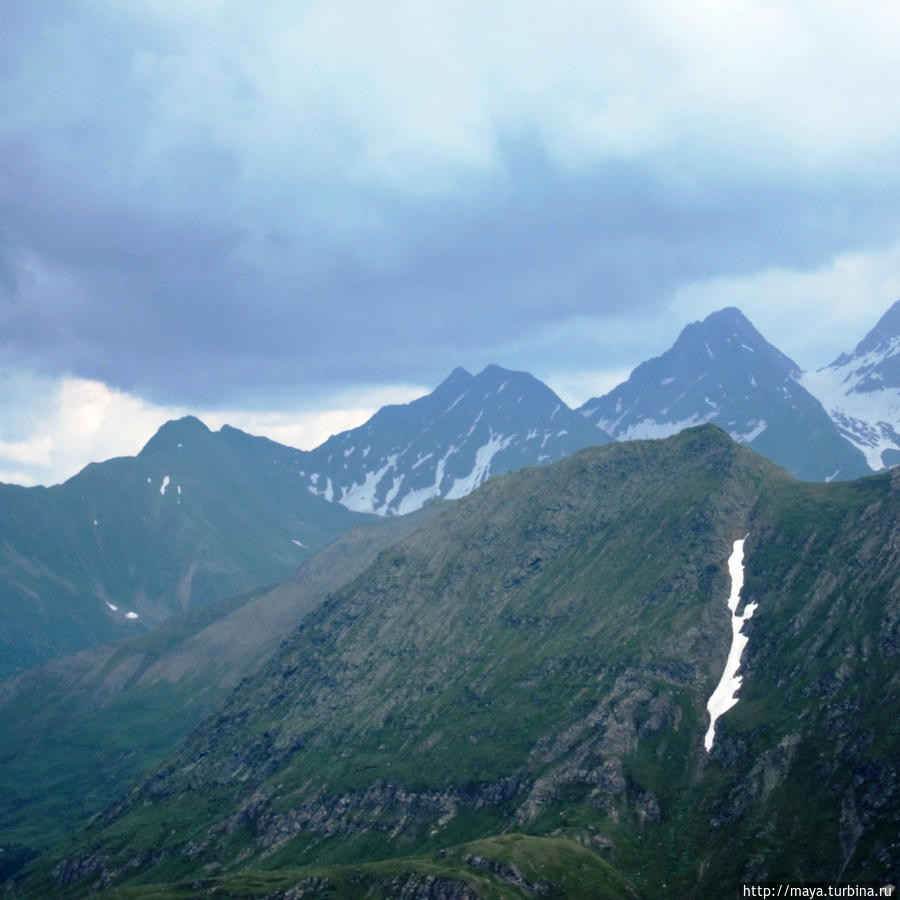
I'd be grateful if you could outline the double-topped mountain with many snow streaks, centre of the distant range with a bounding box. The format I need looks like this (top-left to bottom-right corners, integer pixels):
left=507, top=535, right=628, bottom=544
left=301, top=365, right=611, bottom=515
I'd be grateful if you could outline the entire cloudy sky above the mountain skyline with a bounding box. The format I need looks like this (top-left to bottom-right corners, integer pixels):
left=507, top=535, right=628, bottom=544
left=0, top=0, right=900, bottom=485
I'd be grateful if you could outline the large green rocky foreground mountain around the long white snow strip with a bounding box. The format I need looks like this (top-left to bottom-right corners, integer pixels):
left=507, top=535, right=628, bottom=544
left=10, top=425, right=900, bottom=900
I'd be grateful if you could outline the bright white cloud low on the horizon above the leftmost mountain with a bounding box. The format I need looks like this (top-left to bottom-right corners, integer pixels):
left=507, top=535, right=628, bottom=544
left=0, top=376, right=427, bottom=485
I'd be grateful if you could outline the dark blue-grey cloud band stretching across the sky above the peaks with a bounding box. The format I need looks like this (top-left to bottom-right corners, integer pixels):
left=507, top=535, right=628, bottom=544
left=0, top=4, right=900, bottom=404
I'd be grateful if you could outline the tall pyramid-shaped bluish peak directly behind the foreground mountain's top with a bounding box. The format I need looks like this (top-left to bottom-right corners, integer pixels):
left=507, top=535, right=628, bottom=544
left=580, top=307, right=866, bottom=480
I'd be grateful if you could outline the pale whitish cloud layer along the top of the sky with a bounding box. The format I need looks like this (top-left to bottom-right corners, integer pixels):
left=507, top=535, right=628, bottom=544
left=15, top=0, right=900, bottom=202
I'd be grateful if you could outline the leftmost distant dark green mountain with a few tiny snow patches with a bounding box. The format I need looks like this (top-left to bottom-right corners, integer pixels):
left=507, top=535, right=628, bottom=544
left=0, top=417, right=368, bottom=675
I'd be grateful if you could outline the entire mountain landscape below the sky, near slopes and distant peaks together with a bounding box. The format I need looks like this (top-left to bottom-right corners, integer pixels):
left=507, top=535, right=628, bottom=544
left=0, top=304, right=900, bottom=900
